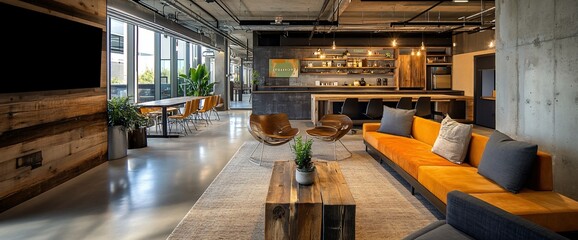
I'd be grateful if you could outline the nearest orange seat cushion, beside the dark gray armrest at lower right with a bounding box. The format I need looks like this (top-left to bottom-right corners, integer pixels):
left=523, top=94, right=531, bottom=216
left=472, top=191, right=578, bottom=232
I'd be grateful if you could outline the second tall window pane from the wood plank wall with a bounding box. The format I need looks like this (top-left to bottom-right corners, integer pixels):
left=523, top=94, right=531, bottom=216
left=136, top=27, right=155, bottom=102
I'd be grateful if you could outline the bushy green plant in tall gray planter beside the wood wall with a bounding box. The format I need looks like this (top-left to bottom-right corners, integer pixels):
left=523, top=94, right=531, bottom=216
left=107, top=97, right=148, bottom=159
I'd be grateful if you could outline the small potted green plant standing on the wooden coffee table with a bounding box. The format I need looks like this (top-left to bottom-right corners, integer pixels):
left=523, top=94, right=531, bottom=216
left=291, top=136, right=315, bottom=185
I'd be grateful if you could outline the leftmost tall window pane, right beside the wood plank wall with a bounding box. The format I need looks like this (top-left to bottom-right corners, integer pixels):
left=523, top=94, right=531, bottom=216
left=109, top=19, right=127, bottom=97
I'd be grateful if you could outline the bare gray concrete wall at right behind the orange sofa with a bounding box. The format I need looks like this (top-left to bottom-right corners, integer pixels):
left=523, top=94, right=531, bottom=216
left=496, top=0, right=578, bottom=200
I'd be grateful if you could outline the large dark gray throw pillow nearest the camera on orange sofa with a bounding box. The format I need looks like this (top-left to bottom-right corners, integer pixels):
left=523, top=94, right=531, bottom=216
left=478, top=130, right=538, bottom=193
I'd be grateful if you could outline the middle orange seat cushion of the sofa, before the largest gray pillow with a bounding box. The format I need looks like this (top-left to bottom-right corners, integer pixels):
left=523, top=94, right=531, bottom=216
left=417, top=166, right=506, bottom=203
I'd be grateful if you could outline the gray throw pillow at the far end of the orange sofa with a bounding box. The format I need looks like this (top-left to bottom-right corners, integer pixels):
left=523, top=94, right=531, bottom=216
left=377, top=106, right=415, bottom=137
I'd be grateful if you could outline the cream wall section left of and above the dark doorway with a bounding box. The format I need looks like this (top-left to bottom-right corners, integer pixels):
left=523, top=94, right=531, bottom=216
left=452, top=49, right=497, bottom=96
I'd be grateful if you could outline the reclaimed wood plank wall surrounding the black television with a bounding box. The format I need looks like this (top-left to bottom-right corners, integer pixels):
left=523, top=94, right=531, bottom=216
left=0, top=0, right=108, bottom=212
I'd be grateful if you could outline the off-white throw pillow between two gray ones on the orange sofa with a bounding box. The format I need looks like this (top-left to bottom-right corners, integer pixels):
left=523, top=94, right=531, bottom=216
left=431, top=115, right=473, bottom=164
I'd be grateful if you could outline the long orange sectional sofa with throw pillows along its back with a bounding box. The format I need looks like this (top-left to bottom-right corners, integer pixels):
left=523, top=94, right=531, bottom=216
left=363, top=117, right=578, bottom=232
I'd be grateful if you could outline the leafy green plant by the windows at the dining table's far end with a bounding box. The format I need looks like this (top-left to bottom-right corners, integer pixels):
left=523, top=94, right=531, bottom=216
left=179, top=64, right=215, bottom=96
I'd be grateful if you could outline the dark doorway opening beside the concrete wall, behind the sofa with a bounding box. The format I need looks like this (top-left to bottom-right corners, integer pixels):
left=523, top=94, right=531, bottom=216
left=474, top=53, right=496, bottom=129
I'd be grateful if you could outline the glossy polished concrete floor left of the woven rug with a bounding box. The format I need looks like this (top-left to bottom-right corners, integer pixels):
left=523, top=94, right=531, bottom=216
left=0, top=110, right=491, bottom=240
